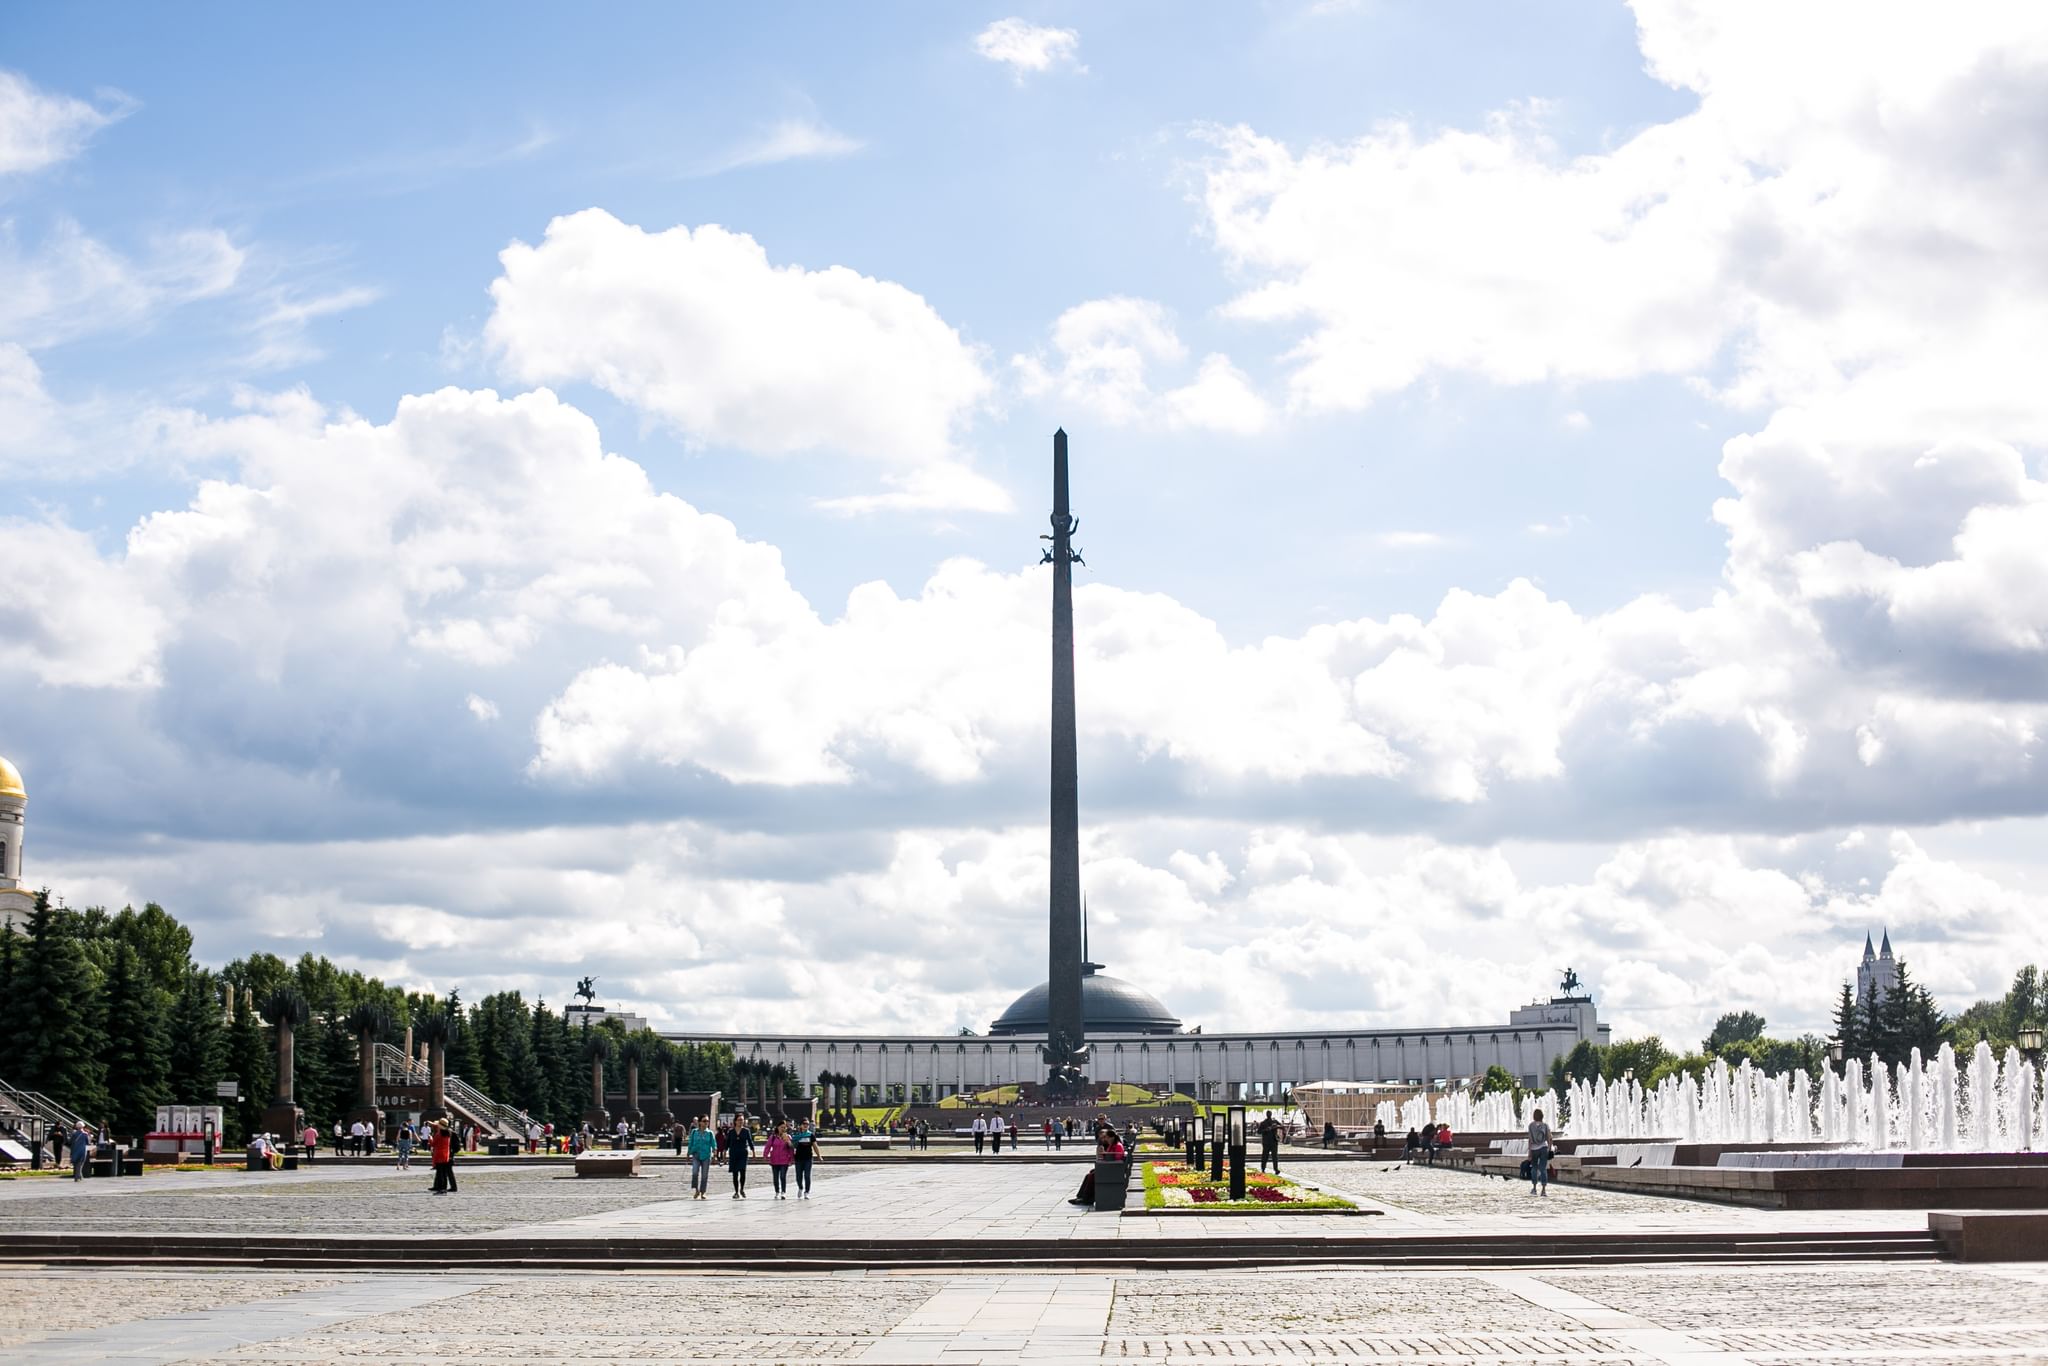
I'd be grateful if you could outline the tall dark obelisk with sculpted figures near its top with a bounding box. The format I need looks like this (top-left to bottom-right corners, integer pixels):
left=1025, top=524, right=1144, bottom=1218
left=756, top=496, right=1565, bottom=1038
left=1038, top=430, right=1087, bottom=1092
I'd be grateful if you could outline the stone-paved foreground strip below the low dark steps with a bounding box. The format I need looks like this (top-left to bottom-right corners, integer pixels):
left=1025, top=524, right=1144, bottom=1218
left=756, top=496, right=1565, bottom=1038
left=12, top=1264, right=2048, bottom=1366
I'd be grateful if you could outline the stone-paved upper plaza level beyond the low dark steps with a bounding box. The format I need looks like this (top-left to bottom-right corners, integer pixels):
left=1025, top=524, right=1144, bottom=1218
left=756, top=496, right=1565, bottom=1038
left=0, top=1161, right=1966, bottom=1241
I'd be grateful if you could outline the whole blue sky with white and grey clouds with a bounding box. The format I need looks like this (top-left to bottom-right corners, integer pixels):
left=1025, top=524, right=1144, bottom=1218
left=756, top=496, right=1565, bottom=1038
left=0, top=0, right=2048, bottom=1044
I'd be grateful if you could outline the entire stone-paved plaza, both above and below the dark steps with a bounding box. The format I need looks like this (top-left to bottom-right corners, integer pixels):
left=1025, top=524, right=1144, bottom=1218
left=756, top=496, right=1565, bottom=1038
left=0, top=1161, right=2048, bottom=1366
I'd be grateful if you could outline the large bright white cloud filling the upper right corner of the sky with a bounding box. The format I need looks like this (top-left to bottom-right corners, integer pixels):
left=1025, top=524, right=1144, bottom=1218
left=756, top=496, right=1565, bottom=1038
left=1204, top=0, right=2048, bottom=410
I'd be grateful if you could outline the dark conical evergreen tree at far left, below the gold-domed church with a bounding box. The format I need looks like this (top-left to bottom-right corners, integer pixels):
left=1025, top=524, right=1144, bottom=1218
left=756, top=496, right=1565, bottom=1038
left=10, top=891, right=106, bottom=1122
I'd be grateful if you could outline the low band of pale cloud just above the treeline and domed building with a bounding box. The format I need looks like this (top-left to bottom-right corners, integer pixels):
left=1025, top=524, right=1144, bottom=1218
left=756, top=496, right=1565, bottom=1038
left=39, top=819, right=2048, bottom=1049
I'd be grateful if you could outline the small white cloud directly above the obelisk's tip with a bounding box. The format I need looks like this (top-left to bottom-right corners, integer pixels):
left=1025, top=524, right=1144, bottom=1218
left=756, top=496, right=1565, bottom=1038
left=1010, top=297, right=1272, bottom=434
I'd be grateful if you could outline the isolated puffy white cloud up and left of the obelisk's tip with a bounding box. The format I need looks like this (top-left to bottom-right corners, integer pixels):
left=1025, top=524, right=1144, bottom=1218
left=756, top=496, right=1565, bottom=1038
left=485, top=209, right=993, bottom=504
